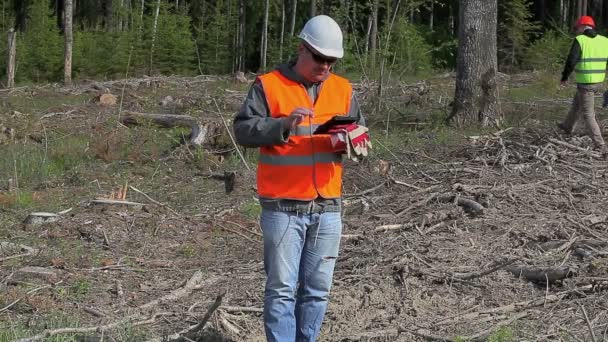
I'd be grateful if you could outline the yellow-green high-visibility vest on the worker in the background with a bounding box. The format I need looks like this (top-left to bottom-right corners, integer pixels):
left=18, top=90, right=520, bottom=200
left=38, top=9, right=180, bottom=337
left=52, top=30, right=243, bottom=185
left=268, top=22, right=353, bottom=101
left=575, top=34, right=608, bottom=83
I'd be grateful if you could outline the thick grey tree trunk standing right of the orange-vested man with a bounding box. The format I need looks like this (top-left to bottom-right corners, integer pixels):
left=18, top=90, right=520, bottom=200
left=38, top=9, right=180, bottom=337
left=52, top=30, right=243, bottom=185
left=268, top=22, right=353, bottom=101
left=448, top=0, right=501, bottom=127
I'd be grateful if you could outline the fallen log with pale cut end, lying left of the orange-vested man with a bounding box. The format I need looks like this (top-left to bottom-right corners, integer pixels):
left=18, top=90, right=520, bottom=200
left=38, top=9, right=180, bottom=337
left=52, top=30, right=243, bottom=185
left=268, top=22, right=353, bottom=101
left=120, top=111, right=213, bottom=146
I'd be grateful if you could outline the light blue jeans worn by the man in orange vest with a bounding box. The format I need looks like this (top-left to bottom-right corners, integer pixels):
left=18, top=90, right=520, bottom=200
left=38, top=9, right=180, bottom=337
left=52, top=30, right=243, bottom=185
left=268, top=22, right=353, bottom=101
left=261, top=209, right=342, bottom=342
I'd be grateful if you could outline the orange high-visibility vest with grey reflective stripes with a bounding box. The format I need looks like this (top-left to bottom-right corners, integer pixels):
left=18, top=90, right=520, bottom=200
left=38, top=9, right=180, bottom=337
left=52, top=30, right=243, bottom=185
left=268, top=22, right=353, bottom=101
left=257, top=70, right=352, bottom=201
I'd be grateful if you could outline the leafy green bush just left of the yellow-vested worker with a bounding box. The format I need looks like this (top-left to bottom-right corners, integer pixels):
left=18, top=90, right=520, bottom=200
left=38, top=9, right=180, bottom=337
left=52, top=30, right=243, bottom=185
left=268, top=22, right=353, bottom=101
left=524, top=31, right=572, bottom=72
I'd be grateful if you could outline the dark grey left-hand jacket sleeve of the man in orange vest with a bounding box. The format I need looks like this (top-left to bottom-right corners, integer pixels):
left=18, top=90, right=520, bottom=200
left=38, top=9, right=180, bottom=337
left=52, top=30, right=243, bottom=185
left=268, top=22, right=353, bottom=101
left=232, top=80, right=289, bottom=147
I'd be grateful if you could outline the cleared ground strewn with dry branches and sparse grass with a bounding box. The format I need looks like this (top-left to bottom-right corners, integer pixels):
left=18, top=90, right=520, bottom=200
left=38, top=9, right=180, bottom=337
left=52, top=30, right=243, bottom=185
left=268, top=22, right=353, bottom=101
left=0, top=76, right=608, bottom=341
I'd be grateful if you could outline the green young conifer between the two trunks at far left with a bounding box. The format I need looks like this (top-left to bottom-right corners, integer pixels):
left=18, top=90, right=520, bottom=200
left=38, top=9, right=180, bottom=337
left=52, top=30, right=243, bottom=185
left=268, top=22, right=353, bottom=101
left=15, top=0, right=63, bottom=82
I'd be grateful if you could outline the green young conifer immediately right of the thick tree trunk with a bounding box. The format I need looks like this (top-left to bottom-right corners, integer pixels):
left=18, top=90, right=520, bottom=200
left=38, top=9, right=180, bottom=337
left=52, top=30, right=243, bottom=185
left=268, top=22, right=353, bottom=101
left=498, top=0, right=540, bottom=66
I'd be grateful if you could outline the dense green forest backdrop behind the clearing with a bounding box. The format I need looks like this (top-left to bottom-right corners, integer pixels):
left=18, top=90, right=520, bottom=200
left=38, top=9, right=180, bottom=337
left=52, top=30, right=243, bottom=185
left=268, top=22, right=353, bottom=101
left=0, top=0, right=608, bottom=84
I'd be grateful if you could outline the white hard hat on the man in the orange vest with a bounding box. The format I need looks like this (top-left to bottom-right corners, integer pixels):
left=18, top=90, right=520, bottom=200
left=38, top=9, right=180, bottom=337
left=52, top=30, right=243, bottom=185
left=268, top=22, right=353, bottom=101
left=298, top=15, right=344, bottom=58
